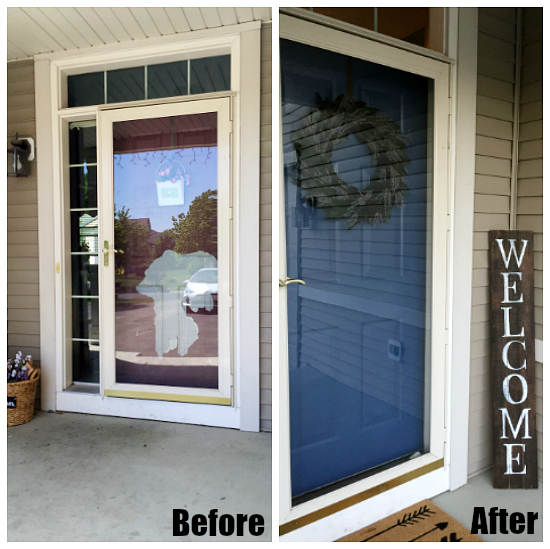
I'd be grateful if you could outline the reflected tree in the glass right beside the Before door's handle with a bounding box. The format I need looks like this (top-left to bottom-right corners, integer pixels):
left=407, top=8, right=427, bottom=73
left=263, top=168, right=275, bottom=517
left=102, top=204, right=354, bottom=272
left=115, top=206, right=151, bottom=272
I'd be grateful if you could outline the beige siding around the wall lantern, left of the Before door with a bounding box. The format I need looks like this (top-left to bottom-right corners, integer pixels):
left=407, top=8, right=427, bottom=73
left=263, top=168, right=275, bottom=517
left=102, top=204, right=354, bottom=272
left=7, top=60, right=40, bottom=394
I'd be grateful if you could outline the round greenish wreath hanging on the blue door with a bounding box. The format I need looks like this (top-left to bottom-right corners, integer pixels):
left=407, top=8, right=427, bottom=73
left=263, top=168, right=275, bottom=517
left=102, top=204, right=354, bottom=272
left=291, top=95, right=410, bottom=229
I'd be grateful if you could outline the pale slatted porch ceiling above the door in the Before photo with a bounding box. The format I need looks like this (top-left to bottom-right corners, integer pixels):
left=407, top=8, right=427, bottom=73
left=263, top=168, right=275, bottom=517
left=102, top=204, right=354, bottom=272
left=7, top=7, right=271, bottom=61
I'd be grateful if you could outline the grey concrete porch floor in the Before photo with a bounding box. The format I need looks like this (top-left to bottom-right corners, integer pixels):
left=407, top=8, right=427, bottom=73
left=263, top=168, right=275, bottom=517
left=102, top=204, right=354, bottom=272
left=7, top=412, right=272, bottom=541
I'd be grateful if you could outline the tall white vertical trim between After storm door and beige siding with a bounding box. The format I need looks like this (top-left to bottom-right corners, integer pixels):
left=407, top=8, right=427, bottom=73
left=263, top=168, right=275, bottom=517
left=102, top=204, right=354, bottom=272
left=448, top=8, right=478, bottom=490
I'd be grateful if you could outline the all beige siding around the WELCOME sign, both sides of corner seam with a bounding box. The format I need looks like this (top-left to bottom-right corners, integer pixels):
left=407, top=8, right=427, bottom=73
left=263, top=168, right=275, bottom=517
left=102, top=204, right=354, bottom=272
left=468, top=8, right=542, bottom=475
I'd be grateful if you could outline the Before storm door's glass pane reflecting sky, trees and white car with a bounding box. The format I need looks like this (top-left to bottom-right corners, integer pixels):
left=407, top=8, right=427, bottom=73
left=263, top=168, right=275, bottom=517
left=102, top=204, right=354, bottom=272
left=113, top=113, right=218, bottom=389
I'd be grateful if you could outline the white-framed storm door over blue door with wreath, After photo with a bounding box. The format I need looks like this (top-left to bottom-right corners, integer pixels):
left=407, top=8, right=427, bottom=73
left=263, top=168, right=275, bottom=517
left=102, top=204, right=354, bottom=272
left=279, top=18, right=450, bottom=533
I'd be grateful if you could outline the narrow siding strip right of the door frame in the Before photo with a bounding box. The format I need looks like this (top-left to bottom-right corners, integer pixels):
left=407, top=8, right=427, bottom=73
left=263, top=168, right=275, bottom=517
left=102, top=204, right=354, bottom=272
left=260, top=24, right=272, bottom=431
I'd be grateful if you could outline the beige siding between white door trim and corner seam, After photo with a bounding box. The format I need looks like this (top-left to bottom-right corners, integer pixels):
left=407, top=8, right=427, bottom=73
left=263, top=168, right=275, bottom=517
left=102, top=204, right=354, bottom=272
left=468, top=8, right=516, bottom=475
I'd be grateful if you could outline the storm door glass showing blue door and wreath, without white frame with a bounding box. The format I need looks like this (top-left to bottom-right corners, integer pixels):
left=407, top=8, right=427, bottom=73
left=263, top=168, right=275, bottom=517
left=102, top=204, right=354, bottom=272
left=281, top=40, right=433, bottom=504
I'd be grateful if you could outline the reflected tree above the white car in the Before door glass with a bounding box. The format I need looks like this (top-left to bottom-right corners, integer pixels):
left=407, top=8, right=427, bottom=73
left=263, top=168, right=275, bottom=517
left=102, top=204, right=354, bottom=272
left=170, top=190, right=218, bottom=257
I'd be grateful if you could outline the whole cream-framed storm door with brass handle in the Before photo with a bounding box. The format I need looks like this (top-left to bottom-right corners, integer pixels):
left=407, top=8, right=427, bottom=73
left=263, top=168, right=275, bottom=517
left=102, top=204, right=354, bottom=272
left=98, top=98, right=232, bottom=406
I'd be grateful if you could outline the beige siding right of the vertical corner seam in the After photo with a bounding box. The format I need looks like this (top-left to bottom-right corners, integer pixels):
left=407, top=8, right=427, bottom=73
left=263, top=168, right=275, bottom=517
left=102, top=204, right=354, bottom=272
left=517, top=8, right=542, bottom=478
